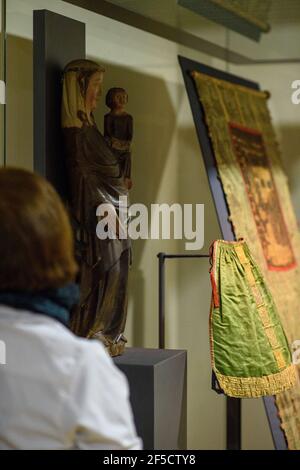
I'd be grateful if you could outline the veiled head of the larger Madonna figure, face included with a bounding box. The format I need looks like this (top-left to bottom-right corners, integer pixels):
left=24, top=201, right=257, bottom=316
left=62, top=59, right=105, bottom=127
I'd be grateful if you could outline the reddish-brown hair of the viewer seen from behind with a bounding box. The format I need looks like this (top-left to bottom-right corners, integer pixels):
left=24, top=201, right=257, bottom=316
left=0, top=168, right=77, bottom=291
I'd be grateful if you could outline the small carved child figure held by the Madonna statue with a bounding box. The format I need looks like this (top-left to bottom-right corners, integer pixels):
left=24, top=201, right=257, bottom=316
left=104, top=88, right=133, bottom=189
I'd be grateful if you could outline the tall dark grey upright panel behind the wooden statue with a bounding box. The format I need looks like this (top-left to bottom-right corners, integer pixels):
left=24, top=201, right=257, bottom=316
left=33, top=10, right=86, bottom=197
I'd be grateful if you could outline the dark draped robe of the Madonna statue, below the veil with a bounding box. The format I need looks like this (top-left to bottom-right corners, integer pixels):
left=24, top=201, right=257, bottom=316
left=64, top=126, right=130, bottom=338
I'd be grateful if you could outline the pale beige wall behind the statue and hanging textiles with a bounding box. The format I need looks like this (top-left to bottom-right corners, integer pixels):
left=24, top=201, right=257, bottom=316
left=7, top=0, right=300, bottom=449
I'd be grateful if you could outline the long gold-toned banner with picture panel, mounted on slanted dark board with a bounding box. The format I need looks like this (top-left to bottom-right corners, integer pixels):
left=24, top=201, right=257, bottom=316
left=192, top=71, right=300, bottom=449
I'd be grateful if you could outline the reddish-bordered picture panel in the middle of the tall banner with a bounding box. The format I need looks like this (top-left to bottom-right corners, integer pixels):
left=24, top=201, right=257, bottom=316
left=229, top=123, right=296, bottom=270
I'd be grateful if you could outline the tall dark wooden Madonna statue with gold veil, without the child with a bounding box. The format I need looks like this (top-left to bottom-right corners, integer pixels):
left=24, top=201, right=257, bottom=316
left=62, top=60, right=131, bottom=356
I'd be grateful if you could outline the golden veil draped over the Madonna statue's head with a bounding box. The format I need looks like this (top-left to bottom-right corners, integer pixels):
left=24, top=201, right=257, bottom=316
left=61, top=59, right=105, bottom=128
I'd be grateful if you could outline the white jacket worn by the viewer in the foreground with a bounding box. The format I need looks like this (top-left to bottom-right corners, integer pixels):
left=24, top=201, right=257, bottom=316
left=0, top=305, right=141, bottom=450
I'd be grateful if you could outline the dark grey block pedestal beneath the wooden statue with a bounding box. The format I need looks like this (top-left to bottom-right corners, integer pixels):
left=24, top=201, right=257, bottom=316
left=114, top=348, right=187, bottom=450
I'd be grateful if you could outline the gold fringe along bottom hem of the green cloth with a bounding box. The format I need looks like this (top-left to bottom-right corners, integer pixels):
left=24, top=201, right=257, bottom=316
left=215, top=364, right=297, bottom=398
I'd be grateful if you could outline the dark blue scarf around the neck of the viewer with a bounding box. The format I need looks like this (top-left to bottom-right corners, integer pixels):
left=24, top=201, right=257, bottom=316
left=0, top=284, right=79, bottom=326
